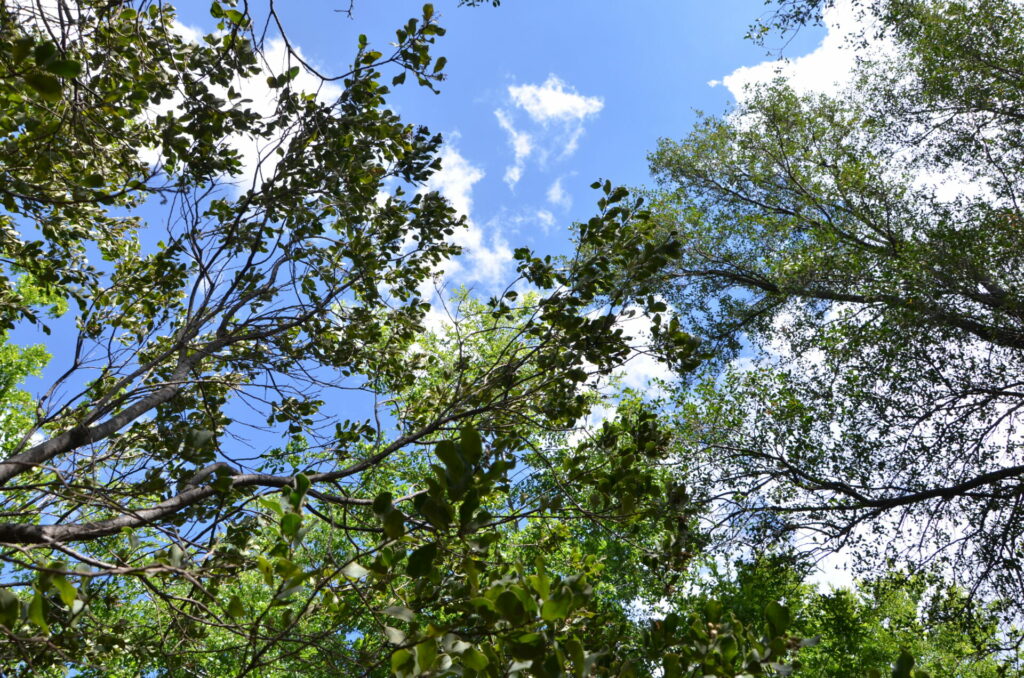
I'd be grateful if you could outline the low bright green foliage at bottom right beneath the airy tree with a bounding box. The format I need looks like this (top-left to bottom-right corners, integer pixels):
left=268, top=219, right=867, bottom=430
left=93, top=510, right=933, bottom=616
left=676, top=553, right=1021, bottom=678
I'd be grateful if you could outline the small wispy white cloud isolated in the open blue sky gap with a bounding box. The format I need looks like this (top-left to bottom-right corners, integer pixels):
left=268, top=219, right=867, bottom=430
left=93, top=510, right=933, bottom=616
left=495, top=75, right=604, bottom=188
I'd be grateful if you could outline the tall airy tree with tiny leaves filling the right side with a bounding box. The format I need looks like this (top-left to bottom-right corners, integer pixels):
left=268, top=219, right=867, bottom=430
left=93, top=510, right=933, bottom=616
left=641, top=0, right=1024, bottom=611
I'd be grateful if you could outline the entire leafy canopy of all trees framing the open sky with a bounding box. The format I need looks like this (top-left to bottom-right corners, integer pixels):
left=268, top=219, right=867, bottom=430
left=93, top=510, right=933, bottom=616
left=0, top=0, right=1024, bottom=678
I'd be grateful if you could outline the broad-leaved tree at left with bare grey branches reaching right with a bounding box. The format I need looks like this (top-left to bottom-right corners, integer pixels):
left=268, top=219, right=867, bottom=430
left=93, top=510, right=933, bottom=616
left=0, top=0, right=788, bottom=676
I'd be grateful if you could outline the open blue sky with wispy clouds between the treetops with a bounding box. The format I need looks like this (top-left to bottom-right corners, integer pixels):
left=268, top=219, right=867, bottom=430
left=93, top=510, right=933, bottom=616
left=172, top=0, right=821, bottom=293
